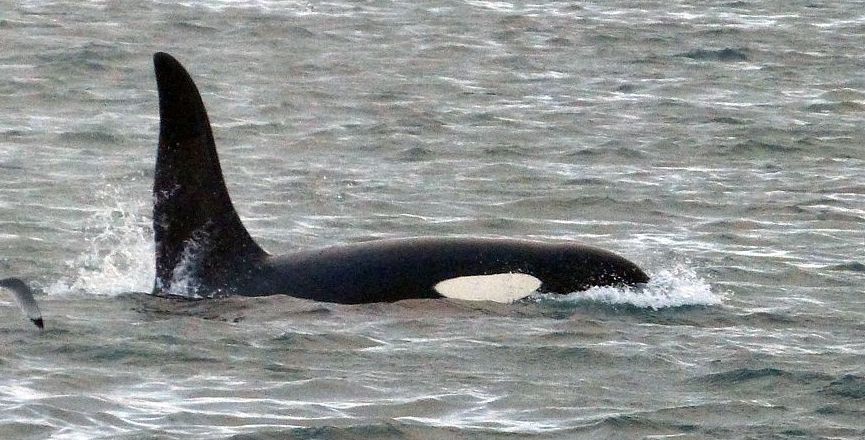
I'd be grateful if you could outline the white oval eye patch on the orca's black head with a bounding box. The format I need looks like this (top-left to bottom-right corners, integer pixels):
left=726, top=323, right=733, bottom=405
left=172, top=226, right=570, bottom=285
left=433, top=273, right=541, bottom=303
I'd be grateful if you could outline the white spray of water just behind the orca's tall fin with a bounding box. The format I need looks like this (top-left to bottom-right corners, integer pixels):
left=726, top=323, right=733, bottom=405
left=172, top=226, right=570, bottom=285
left=46, top=186, right=155, bottom=295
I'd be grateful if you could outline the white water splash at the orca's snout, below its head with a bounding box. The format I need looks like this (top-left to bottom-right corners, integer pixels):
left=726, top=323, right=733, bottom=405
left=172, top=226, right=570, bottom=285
left=541, top=265, right=726, bottom=310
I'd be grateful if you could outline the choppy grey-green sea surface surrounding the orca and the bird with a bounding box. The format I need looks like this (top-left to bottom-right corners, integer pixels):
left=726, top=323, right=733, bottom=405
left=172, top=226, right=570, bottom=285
left=0, top=0, right=865, bottom=439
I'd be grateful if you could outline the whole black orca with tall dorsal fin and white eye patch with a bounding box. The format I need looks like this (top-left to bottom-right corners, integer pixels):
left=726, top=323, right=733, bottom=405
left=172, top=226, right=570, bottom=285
left=153, top=52, right=649, bottom=304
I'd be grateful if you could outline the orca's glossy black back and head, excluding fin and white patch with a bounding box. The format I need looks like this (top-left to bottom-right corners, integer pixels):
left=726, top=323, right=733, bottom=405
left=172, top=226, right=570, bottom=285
left=235, top=237, right=649, bottom=304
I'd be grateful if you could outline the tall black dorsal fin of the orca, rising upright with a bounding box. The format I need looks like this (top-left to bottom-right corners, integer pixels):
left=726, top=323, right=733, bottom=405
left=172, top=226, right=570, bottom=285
left=153, top=52, right=267, bottom=296
